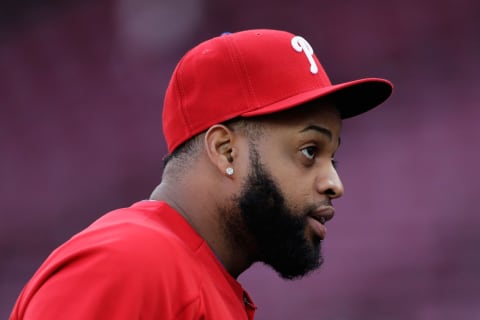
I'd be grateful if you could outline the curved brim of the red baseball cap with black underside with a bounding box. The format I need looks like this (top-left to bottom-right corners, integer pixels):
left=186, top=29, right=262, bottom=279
left=242, top=78, right=393, bottom=119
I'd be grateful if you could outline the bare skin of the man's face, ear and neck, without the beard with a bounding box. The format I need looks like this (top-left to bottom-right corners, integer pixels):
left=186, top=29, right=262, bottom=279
left=151, top=102, right=343, bottom=278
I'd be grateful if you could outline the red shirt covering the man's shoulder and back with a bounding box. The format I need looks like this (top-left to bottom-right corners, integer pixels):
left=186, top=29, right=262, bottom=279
left=10, top=201, right=256, bottom=320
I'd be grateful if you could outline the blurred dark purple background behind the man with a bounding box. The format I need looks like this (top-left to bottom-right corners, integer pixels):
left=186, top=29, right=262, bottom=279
left=0, top=0, right=480, bottom=320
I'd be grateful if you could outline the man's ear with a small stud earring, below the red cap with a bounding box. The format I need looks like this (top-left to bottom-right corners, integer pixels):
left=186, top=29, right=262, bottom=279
left=205, top=124, right=236, bottom=175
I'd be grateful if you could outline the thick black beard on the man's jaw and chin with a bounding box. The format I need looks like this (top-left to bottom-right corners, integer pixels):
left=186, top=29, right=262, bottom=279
left=230, top=146, right=323, bottom=279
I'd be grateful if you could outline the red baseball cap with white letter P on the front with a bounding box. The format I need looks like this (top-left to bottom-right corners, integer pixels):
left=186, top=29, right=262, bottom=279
left=163, top=29, right=393, bottom=153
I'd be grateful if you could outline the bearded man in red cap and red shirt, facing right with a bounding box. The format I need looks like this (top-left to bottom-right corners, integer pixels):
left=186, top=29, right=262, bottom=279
left=10, top=30, right=392, bottom=320
